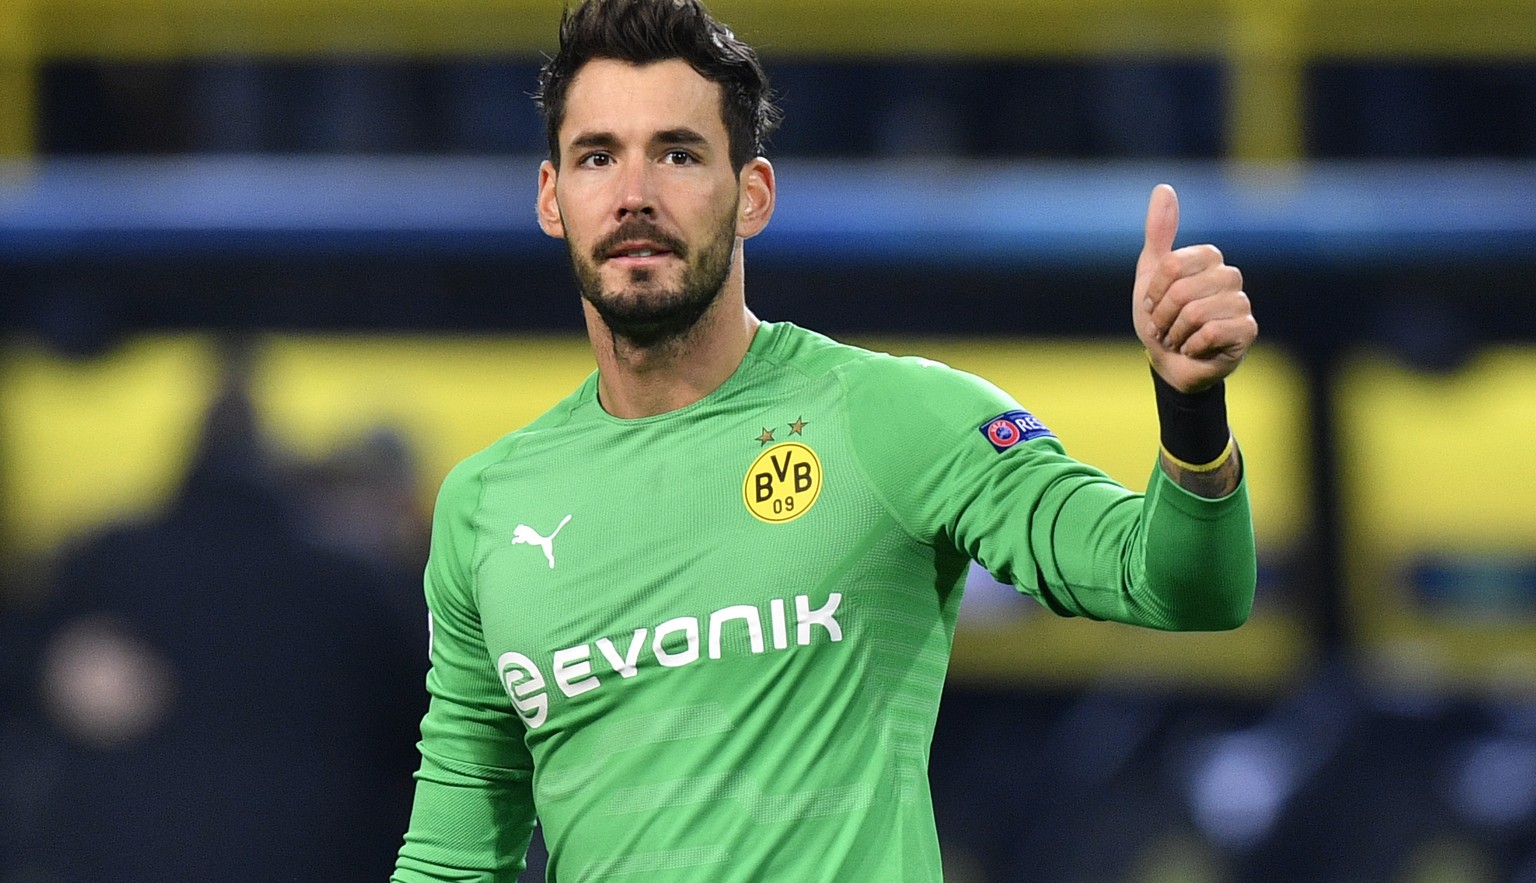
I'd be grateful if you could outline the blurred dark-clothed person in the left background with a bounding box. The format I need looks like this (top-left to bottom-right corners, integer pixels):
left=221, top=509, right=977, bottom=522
left=18, top=342, right=425, bottom=881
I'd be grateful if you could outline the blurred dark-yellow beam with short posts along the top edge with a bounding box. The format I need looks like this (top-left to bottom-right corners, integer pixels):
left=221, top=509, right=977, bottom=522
left=0, top=0, right=1536, bottom=160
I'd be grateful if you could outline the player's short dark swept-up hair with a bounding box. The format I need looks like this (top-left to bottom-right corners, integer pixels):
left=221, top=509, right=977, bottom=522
left=533, top=0, right=782, bottom=172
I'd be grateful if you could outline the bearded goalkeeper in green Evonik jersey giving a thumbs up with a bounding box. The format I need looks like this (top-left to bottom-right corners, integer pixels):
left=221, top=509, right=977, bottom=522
left=395, top=0, right=1256, bottom=883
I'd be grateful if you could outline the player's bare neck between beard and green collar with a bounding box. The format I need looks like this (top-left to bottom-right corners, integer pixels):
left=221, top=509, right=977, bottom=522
left=584, top=286, right=762, bottom=419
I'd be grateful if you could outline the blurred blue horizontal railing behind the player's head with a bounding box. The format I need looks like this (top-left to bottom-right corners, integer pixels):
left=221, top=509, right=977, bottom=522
left=0, top=157, right=1536, bottom=269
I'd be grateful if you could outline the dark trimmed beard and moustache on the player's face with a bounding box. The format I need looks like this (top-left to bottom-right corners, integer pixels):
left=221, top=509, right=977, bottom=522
left=567, top=206, right=736, bottom=349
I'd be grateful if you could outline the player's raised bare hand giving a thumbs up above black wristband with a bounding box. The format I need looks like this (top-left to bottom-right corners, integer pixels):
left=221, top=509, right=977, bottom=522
left=1132, top=184, right=1258, bottom=393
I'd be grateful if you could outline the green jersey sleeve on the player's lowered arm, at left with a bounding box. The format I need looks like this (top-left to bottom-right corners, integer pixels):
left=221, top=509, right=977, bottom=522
left=390, top=458, right=535, bottom=883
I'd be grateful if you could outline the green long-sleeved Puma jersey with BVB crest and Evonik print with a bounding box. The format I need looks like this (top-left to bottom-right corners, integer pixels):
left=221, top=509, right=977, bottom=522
left=395, top=324, right=1255, bottom=883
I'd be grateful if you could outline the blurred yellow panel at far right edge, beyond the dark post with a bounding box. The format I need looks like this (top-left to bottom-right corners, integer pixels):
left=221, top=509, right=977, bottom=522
left=1335, top=347, right=1536, bottom=700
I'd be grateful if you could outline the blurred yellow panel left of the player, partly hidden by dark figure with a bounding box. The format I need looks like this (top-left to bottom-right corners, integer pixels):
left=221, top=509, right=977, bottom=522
left=0, top=335, right=593, bottom=554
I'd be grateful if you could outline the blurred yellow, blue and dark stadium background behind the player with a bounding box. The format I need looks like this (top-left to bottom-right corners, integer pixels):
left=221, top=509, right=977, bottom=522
left=0, top=0, right=1536, bottom=883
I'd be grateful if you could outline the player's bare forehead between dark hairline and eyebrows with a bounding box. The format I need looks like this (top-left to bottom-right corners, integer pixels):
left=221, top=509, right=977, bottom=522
left=561, top=58, right=727, bottom=144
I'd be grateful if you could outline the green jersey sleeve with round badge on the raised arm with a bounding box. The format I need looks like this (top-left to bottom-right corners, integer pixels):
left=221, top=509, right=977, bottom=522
left=845, top=359, right=1256, bottom=630
